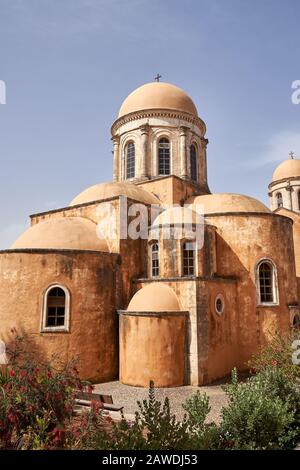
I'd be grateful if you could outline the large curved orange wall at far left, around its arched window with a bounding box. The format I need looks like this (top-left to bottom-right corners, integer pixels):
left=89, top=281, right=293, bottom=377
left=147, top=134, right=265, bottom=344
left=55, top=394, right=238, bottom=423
left=0, top=250, right=118, bottom=382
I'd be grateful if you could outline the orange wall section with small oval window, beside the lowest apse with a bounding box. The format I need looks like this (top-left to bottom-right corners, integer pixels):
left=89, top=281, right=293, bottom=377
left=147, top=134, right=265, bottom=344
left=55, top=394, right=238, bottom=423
left=132, top=278, right=238, bottom=385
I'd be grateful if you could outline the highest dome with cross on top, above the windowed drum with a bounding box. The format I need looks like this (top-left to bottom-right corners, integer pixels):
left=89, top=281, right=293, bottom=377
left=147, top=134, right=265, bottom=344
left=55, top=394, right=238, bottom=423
left=118, top=82, right=198, bottom=118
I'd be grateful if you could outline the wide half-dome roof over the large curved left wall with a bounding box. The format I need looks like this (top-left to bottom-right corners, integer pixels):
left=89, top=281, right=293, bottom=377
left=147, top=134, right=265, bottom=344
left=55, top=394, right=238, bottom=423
left=11, top=217, right=109, bottom=252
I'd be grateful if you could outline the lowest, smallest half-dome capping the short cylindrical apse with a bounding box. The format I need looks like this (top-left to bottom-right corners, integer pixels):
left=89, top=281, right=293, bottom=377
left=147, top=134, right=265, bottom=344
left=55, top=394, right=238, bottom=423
left=127, top=282, right=182, bottom=312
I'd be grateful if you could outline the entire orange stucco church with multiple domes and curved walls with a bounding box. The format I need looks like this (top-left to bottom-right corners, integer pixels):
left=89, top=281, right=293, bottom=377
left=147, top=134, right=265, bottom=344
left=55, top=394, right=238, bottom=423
left=0, top=81, right=300, bottom=387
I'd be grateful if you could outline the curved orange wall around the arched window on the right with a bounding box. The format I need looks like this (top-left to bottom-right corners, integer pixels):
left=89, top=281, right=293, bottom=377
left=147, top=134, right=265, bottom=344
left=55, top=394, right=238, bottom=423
left=207, top=214, right=297, bottom=368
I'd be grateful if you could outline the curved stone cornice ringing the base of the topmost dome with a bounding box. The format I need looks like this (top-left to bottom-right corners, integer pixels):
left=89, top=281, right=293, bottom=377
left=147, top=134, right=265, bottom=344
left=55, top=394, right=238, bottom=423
left=111, top=109, right=206, bottom=136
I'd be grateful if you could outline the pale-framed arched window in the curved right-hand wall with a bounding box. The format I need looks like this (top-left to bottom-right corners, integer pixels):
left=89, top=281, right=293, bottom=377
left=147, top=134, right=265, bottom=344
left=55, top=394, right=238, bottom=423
left=257, top=260, right=278, bottom=304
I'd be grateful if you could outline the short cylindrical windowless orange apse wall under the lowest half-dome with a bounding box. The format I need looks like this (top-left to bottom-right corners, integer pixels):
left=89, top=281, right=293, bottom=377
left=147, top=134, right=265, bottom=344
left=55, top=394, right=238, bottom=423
left=120, top=312, right=186, bottom=387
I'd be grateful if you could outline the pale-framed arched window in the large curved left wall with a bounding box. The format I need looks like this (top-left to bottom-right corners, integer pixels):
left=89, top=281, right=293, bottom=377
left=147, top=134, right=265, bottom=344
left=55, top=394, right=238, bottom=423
left=42, top=285, right=70, bottom=331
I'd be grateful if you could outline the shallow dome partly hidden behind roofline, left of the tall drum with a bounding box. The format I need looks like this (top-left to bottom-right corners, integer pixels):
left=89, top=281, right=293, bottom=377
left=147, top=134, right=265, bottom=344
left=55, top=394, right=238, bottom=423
left=70, top=182, right=160, bottom=206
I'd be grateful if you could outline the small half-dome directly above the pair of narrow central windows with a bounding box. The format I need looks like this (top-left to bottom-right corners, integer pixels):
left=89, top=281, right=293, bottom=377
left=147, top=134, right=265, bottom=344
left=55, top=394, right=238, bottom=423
left=152, top=206, right=204, bottom=228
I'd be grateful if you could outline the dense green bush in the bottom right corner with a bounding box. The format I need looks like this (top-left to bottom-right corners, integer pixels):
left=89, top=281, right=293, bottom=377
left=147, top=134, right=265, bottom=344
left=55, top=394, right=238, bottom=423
left=221, top=367, right=299, bottom=449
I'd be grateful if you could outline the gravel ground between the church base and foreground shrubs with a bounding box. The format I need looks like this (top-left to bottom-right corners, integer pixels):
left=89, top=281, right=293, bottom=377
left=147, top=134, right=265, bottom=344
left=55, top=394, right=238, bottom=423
left=94, top=381, right=226, bottom=422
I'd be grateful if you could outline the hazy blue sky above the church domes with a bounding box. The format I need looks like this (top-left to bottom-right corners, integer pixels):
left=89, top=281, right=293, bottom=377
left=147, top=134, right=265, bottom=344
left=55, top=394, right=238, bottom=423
left=0, top=0, right=300, bottom=248
